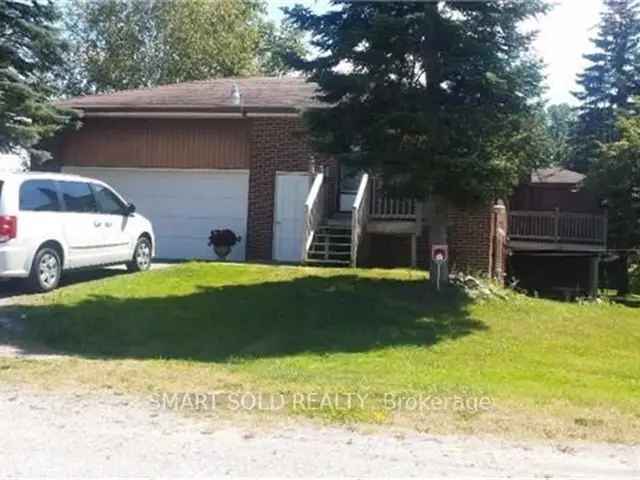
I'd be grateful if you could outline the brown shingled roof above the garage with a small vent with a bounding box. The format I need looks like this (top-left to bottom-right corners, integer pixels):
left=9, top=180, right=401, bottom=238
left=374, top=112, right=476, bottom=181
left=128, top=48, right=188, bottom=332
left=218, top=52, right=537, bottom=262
left=59, top=77, right=322, bottom=112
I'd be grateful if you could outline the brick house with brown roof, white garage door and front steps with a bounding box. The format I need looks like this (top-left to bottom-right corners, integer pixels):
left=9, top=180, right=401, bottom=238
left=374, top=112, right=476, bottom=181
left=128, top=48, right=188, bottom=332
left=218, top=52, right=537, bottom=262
left=50, top=78, right=506, bottom=275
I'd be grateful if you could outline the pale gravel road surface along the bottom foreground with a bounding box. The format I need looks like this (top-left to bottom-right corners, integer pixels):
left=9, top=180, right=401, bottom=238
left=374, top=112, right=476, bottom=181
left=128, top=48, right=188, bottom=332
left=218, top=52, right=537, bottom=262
left=0, top=386, right=640, bottom=479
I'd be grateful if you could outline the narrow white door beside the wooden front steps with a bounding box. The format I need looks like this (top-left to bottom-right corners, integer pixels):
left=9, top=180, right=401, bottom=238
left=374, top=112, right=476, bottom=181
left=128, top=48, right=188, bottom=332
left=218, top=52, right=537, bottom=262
left=273, top=173, right=311, bottom=262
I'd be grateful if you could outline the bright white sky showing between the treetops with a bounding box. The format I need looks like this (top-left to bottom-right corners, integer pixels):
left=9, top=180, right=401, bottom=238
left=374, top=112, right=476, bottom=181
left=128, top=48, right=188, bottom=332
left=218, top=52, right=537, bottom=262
left=268, top=0, right=602, bottom=105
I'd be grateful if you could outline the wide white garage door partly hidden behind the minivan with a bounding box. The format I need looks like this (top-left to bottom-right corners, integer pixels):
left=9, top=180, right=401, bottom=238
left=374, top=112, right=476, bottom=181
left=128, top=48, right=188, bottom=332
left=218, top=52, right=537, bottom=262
left=64, top=167, right=249, bottom=260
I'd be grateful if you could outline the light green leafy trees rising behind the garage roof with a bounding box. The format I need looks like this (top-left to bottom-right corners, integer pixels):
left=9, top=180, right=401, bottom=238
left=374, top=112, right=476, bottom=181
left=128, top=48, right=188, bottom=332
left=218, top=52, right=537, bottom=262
left=63, top=0, right=305, bottom=95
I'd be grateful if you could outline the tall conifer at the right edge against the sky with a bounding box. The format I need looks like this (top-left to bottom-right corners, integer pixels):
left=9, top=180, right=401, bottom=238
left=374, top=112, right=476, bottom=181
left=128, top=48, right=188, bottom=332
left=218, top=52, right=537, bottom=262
left=570, top=0, right=640, bottom=172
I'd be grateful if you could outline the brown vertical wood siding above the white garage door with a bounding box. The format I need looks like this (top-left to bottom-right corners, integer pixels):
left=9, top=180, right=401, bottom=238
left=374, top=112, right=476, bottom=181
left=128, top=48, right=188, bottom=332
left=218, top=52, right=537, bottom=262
left=54, top=118, right=250, bottom=169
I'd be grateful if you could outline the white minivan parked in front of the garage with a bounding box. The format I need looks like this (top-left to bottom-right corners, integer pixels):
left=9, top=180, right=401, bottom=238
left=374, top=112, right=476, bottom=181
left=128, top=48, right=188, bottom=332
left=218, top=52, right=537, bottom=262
left=0, top=173, right=155, bottom=292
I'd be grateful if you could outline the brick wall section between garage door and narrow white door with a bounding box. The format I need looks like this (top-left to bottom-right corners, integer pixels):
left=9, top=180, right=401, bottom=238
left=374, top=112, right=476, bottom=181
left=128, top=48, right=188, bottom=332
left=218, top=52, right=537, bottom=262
left=247, top=117, right=335, bottom=261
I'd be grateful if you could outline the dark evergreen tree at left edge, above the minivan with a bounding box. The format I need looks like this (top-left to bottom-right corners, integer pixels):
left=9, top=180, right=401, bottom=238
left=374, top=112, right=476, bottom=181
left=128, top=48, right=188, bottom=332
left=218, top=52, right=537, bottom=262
left=0, top=0, right=68, bottom=161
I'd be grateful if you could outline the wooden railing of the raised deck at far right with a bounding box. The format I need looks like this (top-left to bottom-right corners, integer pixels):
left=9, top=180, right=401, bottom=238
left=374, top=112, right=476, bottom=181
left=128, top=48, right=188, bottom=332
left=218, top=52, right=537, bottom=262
left=509, top=210, right=607, bottom=244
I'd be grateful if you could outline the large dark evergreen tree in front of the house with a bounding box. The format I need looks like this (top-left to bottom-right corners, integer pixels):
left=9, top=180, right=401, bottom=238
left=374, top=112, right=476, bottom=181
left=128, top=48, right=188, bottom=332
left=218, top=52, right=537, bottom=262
left=287, top=0, right=546, bottom=278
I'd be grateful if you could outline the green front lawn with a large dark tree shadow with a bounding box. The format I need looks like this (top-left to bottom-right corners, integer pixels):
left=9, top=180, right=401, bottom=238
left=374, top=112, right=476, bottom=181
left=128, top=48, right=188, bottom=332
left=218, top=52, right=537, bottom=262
left=0, top=263, right=640, bottom=441
